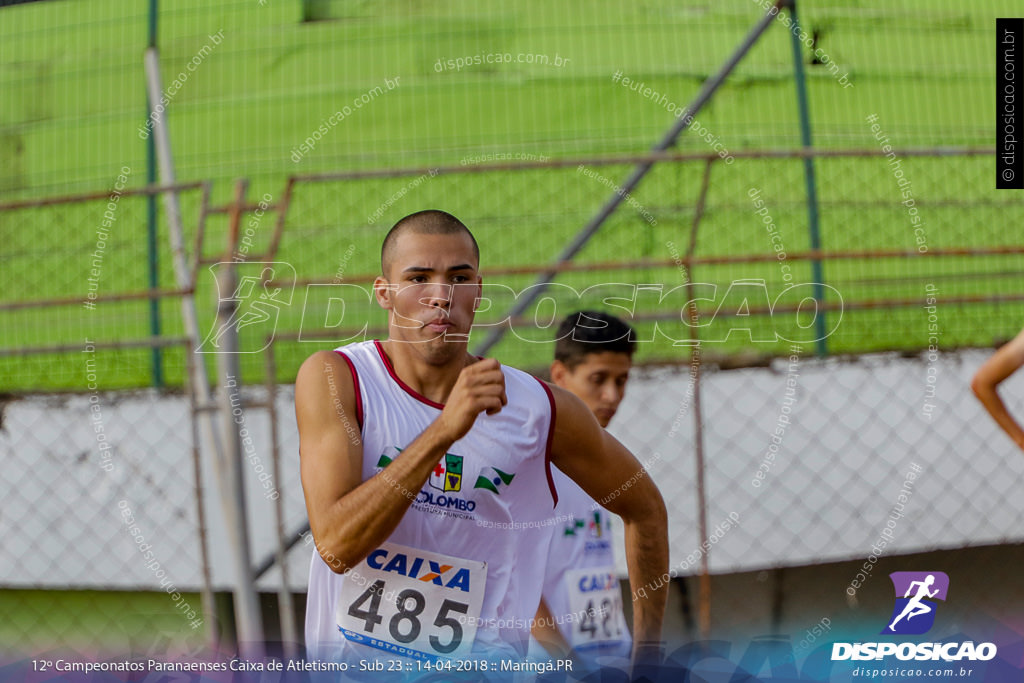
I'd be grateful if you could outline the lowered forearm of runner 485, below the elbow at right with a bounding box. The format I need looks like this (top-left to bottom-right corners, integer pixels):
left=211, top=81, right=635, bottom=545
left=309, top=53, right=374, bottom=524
left=624, top=499, right=669, bottom=644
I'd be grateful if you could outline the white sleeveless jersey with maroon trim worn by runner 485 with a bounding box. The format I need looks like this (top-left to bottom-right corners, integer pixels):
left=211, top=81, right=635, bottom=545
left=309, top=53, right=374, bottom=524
left=305, top=341, right=557, bottom=673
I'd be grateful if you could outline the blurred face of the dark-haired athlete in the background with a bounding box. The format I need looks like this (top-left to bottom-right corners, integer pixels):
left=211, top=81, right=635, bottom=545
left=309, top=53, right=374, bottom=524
left=551, top=351, right=633, bottom=427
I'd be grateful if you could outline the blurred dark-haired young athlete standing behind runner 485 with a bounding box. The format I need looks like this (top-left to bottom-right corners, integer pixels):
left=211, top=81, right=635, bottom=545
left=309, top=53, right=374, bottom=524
left=532, top=310, right=636, bottom=665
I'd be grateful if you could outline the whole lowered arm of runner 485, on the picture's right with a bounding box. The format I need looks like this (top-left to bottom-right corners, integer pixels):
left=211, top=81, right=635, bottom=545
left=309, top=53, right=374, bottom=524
left=551, top=386, right=669, bottom=644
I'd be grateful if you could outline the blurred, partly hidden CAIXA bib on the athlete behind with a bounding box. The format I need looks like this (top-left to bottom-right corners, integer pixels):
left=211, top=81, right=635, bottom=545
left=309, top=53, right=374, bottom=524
left=565, top=567, right=630, bottom=649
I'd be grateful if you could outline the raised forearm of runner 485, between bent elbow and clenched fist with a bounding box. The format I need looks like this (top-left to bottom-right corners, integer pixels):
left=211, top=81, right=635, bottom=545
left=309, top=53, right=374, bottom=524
left=316, top=422, right=454, bottom=573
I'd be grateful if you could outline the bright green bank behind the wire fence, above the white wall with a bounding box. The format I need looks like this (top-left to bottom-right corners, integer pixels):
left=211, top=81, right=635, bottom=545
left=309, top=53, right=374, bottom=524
left=0, top=0, right=1024, bottom=391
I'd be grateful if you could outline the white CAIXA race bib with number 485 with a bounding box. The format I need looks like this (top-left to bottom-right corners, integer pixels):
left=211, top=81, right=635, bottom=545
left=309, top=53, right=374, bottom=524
left=337, top=543, right=487, bottom=659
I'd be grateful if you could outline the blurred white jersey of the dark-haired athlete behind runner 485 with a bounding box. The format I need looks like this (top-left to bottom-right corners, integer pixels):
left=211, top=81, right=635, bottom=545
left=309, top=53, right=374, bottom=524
left=544, top=468, right=632, bottom=658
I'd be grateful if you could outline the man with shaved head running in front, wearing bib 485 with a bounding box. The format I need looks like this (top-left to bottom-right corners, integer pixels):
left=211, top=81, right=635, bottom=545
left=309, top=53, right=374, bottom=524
left=295, top=211, right=668, bottom=673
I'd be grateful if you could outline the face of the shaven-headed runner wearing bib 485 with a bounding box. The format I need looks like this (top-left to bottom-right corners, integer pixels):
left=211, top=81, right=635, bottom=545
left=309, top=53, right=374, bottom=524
left=374, top=232, right=481, bottom=361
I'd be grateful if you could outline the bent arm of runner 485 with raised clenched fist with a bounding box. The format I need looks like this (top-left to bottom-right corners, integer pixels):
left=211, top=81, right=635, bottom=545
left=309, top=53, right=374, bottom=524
left=295, top=351, right=506, bottom=573
